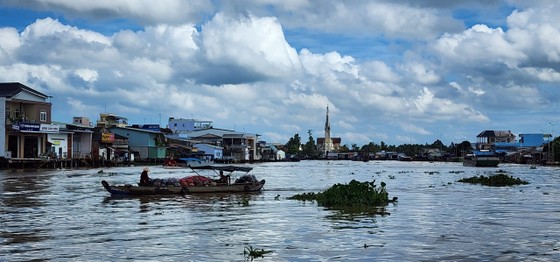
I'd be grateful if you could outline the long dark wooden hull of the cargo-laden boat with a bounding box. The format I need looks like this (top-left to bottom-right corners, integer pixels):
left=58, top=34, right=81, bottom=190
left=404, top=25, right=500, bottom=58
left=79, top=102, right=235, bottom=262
left=101, top=179, right=265, bottom=196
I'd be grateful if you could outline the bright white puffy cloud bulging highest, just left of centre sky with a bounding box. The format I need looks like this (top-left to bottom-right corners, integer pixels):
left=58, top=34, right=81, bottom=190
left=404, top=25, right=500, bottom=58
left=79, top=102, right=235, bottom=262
left=202, top=13, right=300, bottom=81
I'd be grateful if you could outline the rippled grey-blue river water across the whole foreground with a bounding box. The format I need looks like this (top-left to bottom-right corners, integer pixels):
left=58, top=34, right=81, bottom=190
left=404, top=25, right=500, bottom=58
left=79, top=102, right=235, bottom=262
left=0, top=161, right=560, bottom=261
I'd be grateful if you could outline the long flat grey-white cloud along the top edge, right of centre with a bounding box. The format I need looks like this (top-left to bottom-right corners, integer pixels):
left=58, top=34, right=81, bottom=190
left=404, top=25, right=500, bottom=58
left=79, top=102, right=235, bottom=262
left=228, top=0, right=463, bottom=39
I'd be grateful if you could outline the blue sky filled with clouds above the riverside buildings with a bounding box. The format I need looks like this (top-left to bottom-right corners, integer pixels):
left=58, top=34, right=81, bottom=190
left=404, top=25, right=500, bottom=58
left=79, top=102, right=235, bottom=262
left=0, top=0, right=560, bottom=146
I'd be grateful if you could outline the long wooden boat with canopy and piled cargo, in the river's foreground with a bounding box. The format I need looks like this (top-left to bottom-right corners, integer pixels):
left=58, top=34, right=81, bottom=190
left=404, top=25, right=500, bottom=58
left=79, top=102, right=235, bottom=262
left=101, top=166, right=265, bottom=196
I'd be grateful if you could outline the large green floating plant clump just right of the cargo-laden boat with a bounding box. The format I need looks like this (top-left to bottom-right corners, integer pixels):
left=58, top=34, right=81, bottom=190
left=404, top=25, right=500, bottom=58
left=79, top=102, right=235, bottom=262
left=288, top=180, right=397, bottom=207
